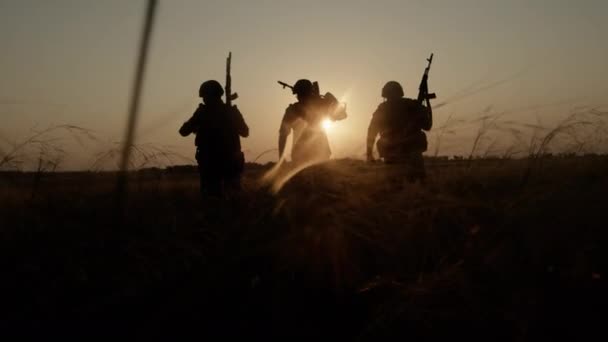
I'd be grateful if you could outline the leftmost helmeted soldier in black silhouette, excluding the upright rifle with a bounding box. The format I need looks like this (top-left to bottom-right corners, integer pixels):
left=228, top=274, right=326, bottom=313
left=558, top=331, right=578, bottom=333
left=179, top=80, right=249, bottom=197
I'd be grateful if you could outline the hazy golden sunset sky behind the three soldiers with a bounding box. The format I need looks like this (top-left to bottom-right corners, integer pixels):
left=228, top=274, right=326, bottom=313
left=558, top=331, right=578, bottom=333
left=0, top=0, right=608, bottom=169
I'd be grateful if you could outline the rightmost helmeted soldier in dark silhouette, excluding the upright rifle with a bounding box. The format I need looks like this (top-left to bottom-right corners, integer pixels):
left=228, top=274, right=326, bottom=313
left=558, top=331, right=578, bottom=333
left=367, top=81, right=432, bottom=181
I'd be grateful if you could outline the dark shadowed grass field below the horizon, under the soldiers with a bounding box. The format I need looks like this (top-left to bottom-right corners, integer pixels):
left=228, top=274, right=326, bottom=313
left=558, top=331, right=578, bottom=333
left=0, top=156, right=608, bottom=341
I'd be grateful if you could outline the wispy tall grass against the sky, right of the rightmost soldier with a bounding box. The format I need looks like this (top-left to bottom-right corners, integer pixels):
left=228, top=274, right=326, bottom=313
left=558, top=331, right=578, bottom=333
left=431, top=107, right=608, bottom=160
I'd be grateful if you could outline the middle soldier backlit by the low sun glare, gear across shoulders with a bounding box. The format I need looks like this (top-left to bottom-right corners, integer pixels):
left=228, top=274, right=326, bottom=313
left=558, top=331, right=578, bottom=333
left=279, top=79, right=347, bottom=164
